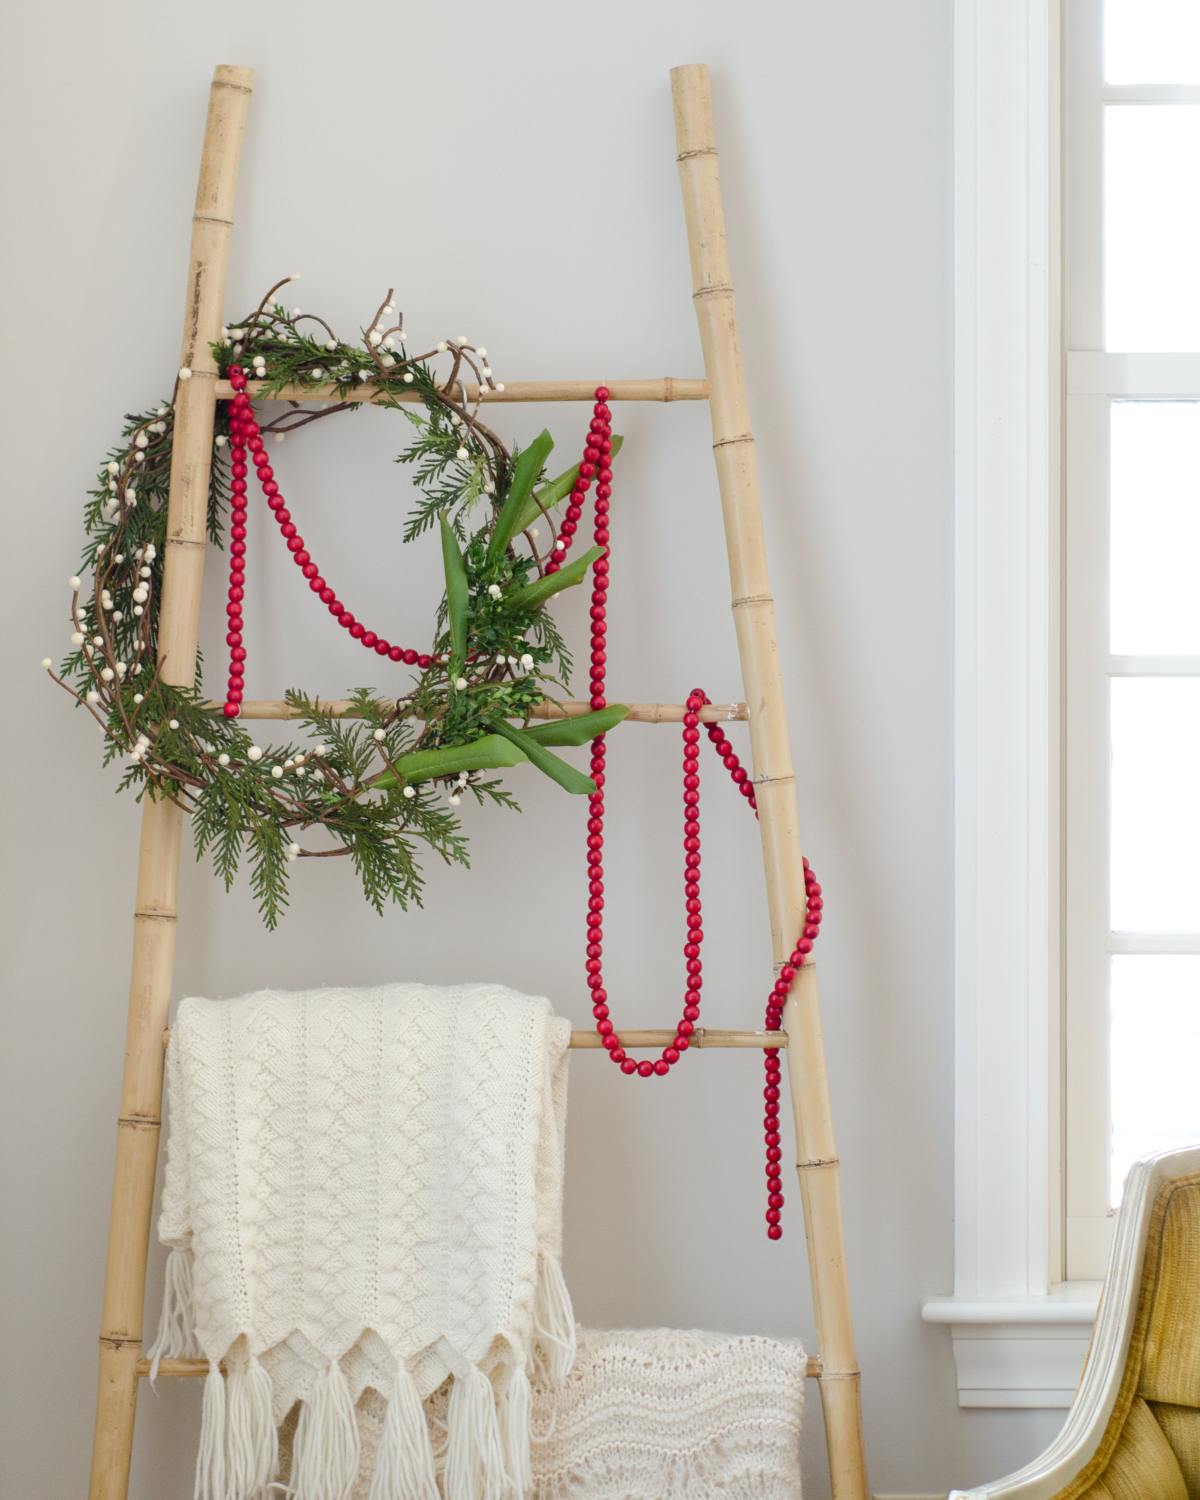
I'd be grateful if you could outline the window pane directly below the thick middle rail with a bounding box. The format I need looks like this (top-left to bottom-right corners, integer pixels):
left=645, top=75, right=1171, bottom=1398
left=1109, top=401, right=1200, bottom=656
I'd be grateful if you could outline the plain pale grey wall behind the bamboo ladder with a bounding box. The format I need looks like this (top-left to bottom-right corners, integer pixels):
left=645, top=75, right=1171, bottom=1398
left=0, top=0, right=1061, bottom=1500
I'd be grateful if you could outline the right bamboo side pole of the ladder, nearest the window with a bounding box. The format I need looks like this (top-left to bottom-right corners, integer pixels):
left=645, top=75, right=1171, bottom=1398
left=671, top=63, right=869, bottom=1500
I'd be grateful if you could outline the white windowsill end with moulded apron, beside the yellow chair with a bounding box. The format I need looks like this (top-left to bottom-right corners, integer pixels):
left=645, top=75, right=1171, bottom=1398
left=921, top=1281, right=1103, bottom=1407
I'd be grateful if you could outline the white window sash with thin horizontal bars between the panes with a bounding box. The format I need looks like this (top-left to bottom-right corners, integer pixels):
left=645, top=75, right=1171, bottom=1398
left=1065, top=0, right=1200, bottom=1278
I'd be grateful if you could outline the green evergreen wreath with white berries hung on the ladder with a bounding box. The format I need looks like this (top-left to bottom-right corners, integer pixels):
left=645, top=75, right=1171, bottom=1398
left=42, top=276, right=627, bottom=929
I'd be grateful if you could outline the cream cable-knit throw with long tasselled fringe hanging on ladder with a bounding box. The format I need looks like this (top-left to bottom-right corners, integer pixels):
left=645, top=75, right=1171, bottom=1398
left=150, top=984, right=575, bottom=1500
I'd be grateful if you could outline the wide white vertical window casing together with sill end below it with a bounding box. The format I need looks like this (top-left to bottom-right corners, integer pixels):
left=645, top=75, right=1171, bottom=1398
left=923, top=0, right=1098, bottom=1407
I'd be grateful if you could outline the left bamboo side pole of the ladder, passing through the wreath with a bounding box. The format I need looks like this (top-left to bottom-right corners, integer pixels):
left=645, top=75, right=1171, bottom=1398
left=89, top=66, right=254, bottom=1500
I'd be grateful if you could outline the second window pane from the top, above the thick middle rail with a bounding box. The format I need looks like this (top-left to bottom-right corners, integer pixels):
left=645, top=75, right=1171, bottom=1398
left=1104, top=105, right=1200, bottom=350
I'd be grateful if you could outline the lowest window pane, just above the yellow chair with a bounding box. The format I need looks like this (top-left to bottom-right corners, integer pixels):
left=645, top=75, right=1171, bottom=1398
left=1110, top=954, right=1200, bottom=1206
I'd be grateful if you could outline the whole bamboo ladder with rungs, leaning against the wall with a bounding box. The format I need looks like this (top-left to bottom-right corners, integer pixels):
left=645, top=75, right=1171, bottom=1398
left=89, top=65, right=867, bottom=1500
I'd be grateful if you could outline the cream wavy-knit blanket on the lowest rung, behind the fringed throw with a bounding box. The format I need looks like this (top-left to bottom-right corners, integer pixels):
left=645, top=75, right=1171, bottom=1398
left=281, top=1328, right=806, bottom=1500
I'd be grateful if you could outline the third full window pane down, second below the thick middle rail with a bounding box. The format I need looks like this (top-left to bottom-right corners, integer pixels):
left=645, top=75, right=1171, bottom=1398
left=1112, top=677, right=1200, bottom=932
